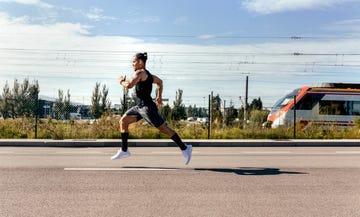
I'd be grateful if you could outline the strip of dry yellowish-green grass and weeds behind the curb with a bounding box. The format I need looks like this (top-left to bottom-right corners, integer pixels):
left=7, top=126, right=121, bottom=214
left=0, top=117, right=360, bottom=140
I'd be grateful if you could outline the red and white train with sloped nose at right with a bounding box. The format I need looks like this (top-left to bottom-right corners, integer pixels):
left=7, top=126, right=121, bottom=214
left=267, top=83, right=360, bottom=128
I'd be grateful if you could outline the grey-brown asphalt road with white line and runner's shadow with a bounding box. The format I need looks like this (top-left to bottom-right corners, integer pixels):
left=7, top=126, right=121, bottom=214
left=0, top=147, right=360, bottom=217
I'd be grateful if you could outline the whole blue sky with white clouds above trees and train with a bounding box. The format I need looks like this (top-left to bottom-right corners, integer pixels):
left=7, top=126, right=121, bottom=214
left=0, top=0, right=360, bottom=107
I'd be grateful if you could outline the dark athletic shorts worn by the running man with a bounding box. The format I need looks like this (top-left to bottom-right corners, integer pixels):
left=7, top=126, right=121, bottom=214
left=125, top=101, right=165, bottom=128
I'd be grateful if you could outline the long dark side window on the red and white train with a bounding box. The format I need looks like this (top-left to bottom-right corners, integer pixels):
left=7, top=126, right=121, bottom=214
left=319, top=100, right=350, bottom=115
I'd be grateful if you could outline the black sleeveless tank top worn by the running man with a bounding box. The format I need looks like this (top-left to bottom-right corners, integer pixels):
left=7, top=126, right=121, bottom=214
left=135, top=69, right=154, bottom=105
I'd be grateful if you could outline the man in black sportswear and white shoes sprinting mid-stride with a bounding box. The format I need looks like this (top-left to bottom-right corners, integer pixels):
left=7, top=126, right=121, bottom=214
left=111, top=53, right=192, bottom=165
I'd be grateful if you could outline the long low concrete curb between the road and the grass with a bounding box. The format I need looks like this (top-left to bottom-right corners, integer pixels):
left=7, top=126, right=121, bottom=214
left=0, top=139, right=360, bottom=147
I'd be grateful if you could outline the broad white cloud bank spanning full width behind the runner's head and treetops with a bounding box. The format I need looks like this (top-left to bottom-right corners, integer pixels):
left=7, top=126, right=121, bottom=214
left=0, top=13, right=360, bottom=105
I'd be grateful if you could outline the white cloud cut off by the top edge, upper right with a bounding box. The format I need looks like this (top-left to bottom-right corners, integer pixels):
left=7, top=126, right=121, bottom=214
left=241, top=0, right=356, bottom=14
